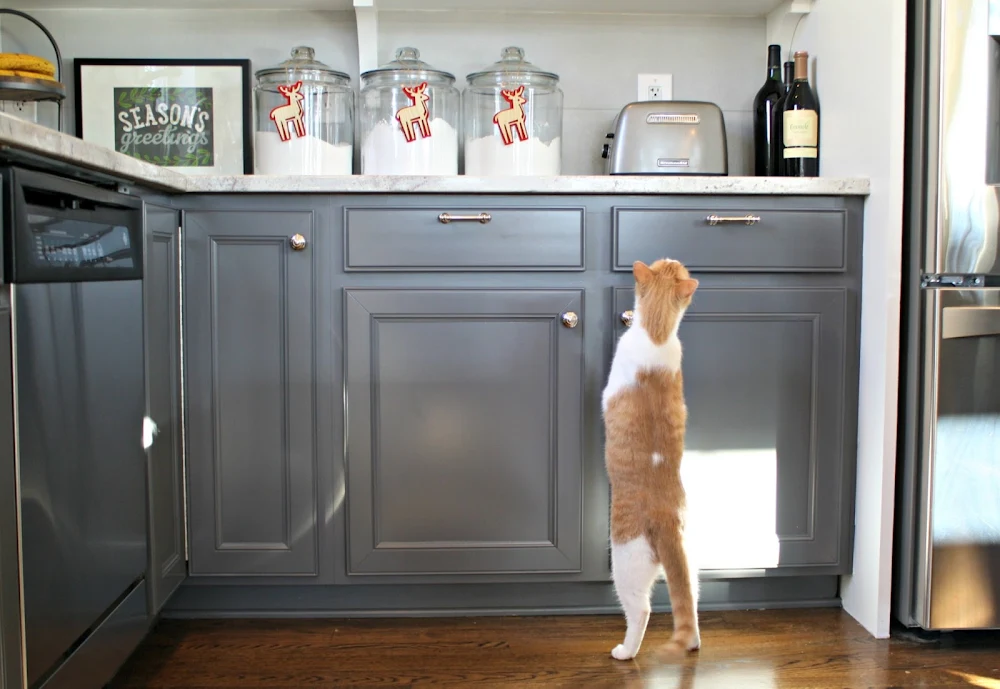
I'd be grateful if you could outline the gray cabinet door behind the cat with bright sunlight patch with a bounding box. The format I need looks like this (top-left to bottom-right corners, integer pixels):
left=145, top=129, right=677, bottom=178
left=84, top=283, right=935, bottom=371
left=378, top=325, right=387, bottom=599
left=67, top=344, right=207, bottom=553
left=614, top=287, right=857, bottom=574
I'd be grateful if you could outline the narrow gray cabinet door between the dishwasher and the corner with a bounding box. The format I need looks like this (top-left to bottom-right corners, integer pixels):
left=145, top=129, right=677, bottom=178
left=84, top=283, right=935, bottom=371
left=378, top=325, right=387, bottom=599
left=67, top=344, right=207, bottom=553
left=143, top=204, right=187, bottom=615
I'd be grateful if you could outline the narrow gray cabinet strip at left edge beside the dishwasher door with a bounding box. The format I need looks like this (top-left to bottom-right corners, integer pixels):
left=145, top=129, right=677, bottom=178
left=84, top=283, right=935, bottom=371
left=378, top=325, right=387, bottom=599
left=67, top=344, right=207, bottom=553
left=0, top=286, right=24, bottom=689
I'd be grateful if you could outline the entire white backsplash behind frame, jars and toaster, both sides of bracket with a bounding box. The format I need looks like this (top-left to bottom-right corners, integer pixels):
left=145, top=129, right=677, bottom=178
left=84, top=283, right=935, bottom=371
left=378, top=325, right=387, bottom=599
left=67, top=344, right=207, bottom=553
left=0, top=8, right=766, bottom=175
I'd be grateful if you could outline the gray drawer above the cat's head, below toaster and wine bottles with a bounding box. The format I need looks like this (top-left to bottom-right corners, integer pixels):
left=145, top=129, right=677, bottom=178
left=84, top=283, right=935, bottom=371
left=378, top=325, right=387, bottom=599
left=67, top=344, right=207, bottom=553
left=613, top=207, right=847, bottom=273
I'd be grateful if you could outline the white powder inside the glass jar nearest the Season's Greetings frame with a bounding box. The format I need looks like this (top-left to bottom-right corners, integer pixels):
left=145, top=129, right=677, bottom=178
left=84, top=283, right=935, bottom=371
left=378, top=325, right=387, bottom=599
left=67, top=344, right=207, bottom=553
left=254, top=132, right=354, bottom=175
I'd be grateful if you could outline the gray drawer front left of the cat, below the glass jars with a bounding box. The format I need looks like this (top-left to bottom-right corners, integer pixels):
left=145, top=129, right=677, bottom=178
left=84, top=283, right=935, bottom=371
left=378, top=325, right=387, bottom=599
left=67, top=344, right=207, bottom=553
left=344, top=206, right=585, bottom=271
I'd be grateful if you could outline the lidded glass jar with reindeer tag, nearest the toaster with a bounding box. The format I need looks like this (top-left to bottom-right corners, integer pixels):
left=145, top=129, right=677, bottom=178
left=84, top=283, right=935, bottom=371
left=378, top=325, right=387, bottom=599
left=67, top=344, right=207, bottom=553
left=462, top=47, right=563, bottom=177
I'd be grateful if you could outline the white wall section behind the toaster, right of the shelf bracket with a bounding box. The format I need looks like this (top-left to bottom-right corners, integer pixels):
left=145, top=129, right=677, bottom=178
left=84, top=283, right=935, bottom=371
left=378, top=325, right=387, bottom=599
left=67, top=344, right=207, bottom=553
left=378, top=12, right=767, bottom=175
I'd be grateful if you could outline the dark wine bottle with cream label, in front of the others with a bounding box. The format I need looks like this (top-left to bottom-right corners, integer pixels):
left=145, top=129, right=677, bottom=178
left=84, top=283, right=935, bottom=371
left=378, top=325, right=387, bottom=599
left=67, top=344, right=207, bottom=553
left=781, top=50, right=819, bottom=177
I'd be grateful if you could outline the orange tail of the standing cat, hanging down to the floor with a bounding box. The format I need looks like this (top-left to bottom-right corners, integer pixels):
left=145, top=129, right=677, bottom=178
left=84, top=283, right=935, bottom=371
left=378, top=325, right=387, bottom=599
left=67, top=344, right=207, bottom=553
left=650, top=518, right=701, bottom=652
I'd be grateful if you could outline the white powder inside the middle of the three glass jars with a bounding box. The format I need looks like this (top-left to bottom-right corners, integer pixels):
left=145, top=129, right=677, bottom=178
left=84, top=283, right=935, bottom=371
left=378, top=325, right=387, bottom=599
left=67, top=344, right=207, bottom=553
left=361, top=117, right=458, bottom=175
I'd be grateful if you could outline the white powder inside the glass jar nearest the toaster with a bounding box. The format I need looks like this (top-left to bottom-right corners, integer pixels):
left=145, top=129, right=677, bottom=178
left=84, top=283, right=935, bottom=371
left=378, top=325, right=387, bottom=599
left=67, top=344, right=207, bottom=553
left=465, top=136, right=562, bottom=177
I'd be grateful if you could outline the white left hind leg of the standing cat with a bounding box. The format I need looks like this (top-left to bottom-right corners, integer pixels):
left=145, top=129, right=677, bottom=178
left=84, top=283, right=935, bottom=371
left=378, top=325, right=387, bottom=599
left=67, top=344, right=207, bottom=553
left=611, top=536, right=659, bottom=660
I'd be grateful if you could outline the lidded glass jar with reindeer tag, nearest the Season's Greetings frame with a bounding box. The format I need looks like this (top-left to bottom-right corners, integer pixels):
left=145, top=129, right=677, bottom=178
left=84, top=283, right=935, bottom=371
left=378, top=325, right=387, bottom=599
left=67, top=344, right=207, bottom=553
left=254, top=46, right=354, bottom=175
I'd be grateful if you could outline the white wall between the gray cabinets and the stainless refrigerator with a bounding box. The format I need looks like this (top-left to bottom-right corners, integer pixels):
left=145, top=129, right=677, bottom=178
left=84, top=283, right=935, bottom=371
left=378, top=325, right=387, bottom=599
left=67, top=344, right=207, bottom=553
left=792, top=0, right=906, bottom=638
